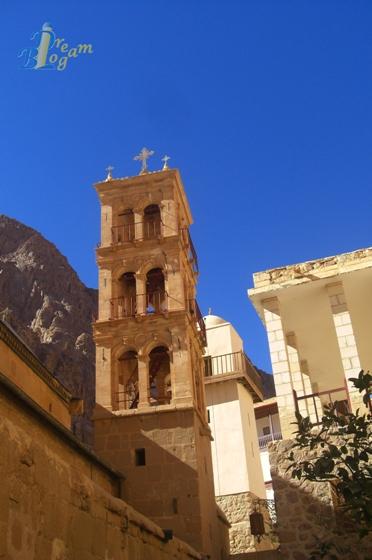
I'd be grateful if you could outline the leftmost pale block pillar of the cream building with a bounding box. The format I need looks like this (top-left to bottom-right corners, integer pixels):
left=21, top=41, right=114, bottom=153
left=262, top=298, right=296, bottom=438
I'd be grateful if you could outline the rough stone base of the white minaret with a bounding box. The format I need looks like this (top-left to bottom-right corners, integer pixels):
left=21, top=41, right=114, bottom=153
left=216, top=492, right=274, bottom=558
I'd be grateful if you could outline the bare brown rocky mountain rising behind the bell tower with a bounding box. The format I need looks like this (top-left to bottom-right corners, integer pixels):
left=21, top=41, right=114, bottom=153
left=0, top=215, right=98, bottom=443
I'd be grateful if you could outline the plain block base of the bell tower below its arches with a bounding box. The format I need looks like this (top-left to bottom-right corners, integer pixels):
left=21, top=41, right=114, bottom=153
left=94, top=406, right=229, bottom=559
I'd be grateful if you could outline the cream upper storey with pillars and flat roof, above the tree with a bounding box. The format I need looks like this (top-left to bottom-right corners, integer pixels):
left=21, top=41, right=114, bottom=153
left=248, top=249, right=372, bottom=438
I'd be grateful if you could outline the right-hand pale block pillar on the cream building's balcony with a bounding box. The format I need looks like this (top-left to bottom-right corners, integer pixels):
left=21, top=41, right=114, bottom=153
left=327, top=282, right=364, bottom=412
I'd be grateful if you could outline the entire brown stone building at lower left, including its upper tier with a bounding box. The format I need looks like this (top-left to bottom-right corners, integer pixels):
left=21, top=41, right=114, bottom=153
left=0, top=321, right=206, bottom=560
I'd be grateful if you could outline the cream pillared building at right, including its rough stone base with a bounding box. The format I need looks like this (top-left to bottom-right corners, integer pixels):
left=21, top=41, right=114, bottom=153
left=248, top=248, right=372, bottom=560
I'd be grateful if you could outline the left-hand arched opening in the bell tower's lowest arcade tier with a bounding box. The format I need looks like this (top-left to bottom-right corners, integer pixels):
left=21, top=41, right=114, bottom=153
left=117, top=350, right=139, bottom=410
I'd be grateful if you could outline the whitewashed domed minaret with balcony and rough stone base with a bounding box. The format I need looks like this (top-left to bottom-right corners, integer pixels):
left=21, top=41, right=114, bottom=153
left=204, top=315, right=272, bottom=557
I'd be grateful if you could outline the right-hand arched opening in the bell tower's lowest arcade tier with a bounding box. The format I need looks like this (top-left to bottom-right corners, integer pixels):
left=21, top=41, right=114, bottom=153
left=149, top=346, right=172, bottom=406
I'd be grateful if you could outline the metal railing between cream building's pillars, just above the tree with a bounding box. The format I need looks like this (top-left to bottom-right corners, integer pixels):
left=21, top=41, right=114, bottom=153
left=293, top=381, right=351, bottom=426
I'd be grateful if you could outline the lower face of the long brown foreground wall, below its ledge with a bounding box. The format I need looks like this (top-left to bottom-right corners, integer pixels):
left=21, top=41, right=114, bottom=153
left=0, top=378, right=201, bottom=560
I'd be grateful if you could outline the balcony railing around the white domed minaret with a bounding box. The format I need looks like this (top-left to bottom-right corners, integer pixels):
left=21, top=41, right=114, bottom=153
left=204, top=351, right=263, bottom=398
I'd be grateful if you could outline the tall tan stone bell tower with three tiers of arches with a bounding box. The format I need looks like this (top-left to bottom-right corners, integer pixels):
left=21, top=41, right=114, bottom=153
left=94, top=160, right=224, bottom=558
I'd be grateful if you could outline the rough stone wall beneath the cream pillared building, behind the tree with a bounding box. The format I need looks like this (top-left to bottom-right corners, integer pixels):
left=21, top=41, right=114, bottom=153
left=269, top=440, right=372, bottom=560
